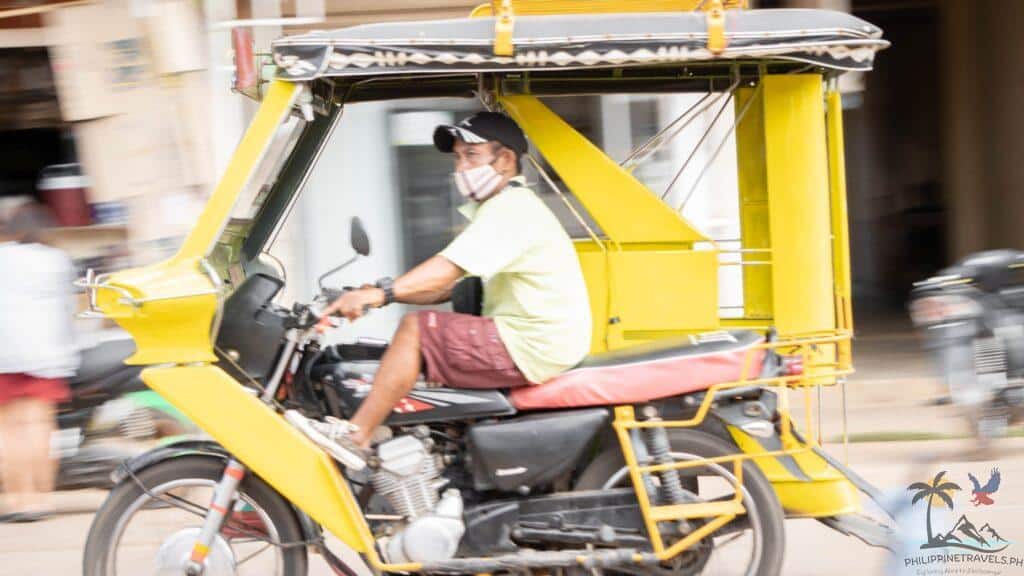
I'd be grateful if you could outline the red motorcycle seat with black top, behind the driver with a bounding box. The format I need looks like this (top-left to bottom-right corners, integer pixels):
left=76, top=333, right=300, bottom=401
left=509, top=331, right=766, bottom=410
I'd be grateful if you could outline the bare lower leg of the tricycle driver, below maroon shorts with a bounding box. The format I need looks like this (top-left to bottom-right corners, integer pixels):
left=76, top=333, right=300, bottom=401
left=351, top=314, right=422, bottom=447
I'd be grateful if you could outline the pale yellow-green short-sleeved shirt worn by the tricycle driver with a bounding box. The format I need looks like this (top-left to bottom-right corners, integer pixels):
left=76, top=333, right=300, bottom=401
left=440, top=176, right=591, bottom=383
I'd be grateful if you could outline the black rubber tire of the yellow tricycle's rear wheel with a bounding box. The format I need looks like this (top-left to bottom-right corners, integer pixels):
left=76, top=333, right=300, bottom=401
left=574, top=429, right=785, bottom=576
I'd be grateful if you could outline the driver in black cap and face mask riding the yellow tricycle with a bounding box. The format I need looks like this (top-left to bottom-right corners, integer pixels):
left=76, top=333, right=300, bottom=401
left=324, top=112, right=591, bottom=452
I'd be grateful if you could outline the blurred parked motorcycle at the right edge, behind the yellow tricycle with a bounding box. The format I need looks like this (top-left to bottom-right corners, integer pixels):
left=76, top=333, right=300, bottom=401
left=909, top=250, right=1024, bottom=443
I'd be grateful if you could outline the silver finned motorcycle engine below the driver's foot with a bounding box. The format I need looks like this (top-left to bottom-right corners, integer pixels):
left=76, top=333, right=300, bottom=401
left=370, top=436, right=466, bottom=563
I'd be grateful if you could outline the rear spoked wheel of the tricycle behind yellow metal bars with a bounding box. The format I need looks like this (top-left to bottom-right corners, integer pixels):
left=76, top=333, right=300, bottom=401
left=575, top=429, right=785, bottom=576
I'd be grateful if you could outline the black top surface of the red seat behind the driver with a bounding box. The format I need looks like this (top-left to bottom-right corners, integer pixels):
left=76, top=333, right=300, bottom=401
left=572, top=330, right=764, bottom=370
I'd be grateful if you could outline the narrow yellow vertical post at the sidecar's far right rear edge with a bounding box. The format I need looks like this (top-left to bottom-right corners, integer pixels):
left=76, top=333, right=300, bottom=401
left=826, top=90, right=853, bottom=342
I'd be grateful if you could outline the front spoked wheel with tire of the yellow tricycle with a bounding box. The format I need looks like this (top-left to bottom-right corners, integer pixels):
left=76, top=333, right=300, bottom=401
left=83, top=456, right=308, bottom=576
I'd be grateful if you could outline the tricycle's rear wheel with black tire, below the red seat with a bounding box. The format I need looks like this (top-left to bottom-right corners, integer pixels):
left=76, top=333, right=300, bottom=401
left=574, top=429, right=785, bottom=576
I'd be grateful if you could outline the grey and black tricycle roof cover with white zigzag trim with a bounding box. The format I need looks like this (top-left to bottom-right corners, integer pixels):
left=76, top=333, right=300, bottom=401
left=272, top=9, right=889, bottom=81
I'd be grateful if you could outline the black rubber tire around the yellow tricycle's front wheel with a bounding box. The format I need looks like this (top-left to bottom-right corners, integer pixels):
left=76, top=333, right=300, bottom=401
left=82, top=456, right=309, bottom=576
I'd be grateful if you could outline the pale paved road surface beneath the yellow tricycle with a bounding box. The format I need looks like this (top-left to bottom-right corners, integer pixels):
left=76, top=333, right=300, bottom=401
left=0, top=439, right=1024, bottom=576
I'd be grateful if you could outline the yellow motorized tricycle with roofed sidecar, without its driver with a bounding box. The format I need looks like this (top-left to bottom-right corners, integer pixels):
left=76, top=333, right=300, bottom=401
left=80, top=0, right=888, bottom=576
